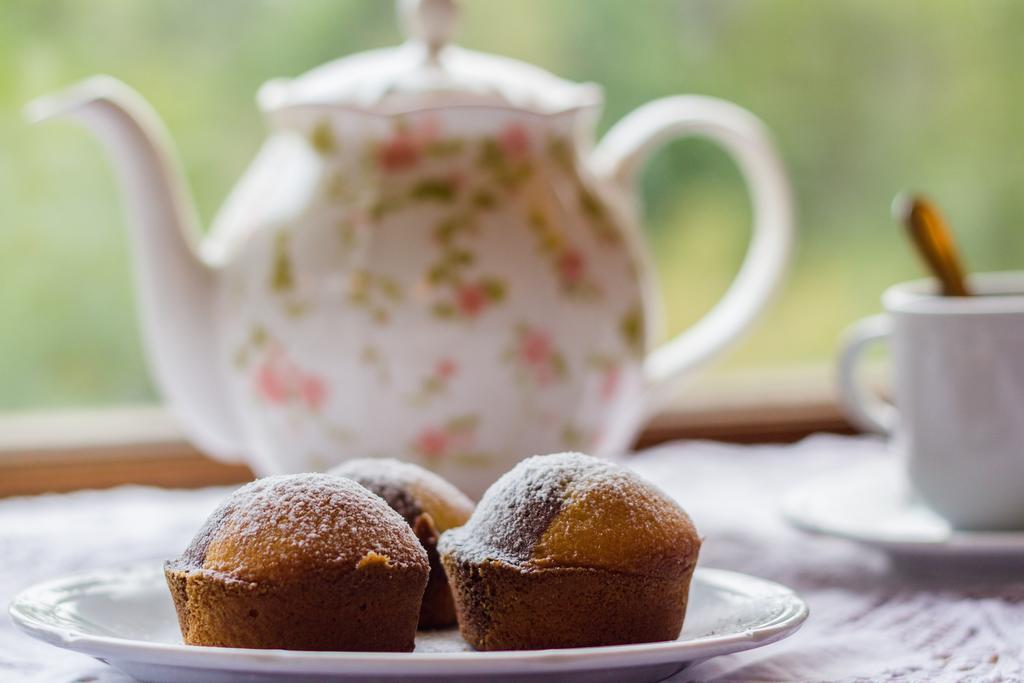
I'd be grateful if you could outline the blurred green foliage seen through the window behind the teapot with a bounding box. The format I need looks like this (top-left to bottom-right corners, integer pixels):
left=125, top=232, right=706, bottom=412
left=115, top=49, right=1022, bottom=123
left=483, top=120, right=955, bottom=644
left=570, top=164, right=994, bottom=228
left=0, top=0, right=1024, bottom=410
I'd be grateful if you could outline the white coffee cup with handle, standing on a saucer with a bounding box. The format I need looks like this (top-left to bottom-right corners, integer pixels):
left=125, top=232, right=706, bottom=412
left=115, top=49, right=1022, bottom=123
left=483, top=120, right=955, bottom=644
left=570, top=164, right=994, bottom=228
left=839, top=272, right=1024, bottom=530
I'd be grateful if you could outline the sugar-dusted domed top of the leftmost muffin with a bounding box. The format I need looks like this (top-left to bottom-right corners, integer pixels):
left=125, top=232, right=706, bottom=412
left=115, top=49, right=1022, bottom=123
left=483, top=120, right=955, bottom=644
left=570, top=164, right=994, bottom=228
left=169, top=474, right=427, bottom=582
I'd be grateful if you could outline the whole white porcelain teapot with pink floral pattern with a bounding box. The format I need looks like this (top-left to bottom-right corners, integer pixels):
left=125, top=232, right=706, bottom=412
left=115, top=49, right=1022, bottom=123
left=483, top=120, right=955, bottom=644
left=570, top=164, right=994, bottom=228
left=29, top=0, right=793, bottom=494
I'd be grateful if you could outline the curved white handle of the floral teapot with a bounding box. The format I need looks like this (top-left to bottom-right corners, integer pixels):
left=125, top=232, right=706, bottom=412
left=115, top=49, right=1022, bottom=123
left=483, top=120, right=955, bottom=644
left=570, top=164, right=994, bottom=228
left=591, top=95, right=794, bottom=415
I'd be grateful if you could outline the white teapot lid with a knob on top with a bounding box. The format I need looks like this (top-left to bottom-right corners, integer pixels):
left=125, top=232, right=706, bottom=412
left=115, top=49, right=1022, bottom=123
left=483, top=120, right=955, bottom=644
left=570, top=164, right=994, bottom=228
left=257, top=0, right=601, bottom=115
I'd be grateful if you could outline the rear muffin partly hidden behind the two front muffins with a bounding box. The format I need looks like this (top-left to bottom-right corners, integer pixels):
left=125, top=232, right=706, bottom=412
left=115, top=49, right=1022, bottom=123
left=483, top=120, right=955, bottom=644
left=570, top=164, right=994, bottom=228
left=330, top=458, right=473, bottom=629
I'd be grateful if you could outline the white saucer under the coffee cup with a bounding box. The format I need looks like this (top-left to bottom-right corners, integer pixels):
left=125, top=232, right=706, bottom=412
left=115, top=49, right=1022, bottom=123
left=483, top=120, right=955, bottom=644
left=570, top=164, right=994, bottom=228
left=782, top=458, right=1024, bottom=561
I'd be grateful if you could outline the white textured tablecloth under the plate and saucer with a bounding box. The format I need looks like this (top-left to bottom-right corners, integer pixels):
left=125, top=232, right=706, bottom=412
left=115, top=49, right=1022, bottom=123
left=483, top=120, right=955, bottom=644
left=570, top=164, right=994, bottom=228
left=0, top=436, right=1024, bottom=683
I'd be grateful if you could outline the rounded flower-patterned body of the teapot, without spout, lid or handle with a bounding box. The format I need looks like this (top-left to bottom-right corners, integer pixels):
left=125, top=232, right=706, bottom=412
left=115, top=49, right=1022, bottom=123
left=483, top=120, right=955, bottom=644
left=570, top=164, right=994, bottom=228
left=221, top=112, right=644, bottom=480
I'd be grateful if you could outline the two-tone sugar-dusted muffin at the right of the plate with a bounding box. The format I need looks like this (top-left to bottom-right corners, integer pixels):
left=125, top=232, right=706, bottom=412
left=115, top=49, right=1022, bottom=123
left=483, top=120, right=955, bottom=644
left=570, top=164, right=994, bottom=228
left=438, top=453, right=700, bottom=650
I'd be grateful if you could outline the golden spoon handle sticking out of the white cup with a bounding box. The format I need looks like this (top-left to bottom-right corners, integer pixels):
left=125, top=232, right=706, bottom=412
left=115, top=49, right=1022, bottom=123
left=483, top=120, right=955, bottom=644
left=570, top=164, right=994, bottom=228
left=892, top=195, right=971, bottom=296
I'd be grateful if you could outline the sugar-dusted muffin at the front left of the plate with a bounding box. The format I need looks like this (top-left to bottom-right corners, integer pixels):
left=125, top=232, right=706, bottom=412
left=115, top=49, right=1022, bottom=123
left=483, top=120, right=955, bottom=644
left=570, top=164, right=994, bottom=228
left=164, top=474, right=429, bottom=651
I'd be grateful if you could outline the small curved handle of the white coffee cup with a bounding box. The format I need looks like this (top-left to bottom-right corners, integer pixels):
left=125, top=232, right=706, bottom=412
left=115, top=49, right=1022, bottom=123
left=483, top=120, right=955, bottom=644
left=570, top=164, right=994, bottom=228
left=839, top=313, right=897, bottom=434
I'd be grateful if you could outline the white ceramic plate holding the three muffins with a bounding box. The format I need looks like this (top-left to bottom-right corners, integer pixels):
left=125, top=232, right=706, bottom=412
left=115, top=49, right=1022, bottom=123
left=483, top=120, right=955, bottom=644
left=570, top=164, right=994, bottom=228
left=10, top=563, right=807, bottom=683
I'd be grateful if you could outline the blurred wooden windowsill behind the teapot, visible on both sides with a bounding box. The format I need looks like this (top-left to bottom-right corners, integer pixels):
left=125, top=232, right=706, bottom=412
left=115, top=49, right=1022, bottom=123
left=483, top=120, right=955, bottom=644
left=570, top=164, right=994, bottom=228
left=0, top=370, right=853, bottom=497
